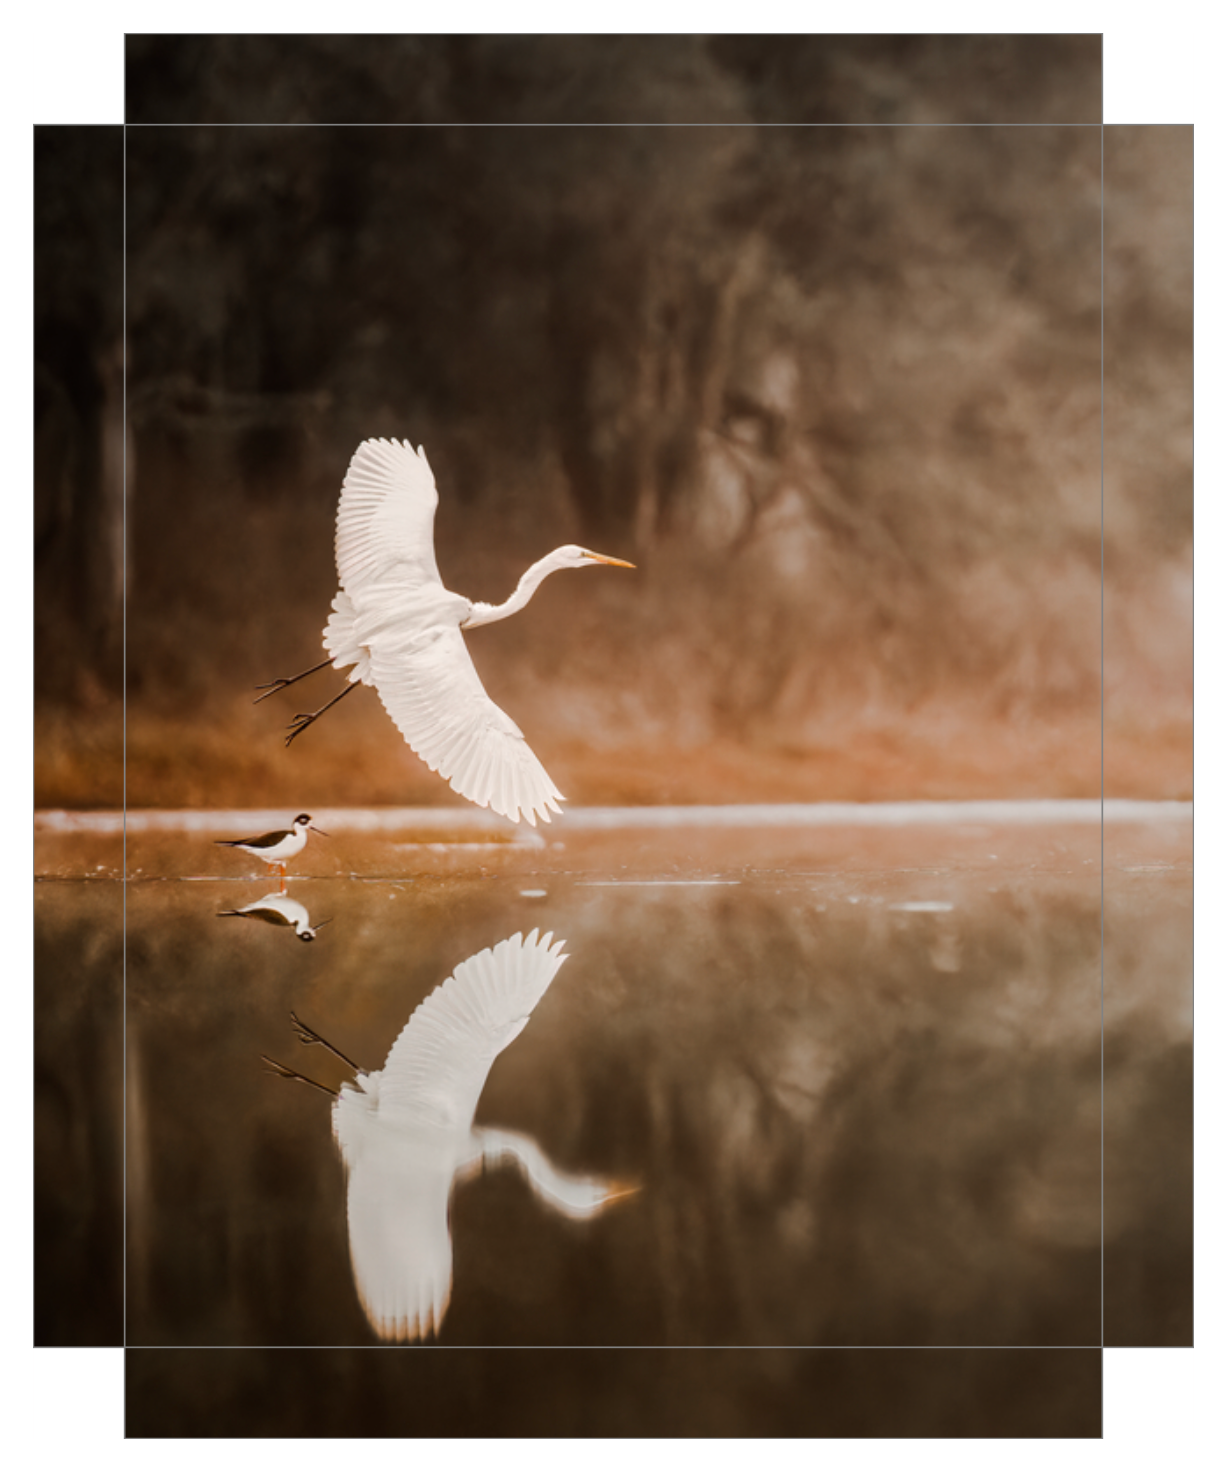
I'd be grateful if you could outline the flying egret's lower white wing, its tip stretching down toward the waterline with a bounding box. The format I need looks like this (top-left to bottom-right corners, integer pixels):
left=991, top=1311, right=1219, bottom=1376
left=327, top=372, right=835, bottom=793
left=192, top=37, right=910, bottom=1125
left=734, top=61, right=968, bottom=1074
left=369, top=625, right=563, bottom=826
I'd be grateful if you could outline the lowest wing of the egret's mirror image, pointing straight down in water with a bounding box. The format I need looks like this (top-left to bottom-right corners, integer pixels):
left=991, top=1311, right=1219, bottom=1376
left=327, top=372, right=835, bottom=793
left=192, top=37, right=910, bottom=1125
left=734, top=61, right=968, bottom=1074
left=347, top=1146, right=454, bottom=1342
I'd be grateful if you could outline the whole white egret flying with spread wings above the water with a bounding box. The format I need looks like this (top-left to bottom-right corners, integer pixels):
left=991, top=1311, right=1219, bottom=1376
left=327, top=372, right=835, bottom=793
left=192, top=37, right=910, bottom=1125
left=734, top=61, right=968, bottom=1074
left=254, top=440, right=632, bottom=826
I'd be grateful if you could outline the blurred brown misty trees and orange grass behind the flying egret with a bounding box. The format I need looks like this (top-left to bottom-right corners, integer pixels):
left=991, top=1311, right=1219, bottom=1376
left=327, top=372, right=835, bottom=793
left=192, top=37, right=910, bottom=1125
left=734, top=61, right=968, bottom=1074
left=35, top=37, right=1192, bottom=810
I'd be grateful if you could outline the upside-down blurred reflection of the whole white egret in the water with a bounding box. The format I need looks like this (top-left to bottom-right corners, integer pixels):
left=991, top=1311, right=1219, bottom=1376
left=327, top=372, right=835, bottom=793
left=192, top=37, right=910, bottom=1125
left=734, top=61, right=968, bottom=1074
left=265, top=931, right=631, bottom=1341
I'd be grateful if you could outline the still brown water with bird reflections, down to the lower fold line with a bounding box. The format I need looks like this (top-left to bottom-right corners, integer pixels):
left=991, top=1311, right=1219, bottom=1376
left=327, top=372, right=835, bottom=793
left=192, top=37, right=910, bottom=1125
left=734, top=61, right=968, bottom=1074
left=35, top=809, right=1192, bottom=1347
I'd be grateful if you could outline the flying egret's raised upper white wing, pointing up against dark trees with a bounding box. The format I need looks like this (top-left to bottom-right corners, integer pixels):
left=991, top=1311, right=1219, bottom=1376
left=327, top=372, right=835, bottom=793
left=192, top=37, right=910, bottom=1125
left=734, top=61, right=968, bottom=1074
left=334, top=440, right=441, bottom=598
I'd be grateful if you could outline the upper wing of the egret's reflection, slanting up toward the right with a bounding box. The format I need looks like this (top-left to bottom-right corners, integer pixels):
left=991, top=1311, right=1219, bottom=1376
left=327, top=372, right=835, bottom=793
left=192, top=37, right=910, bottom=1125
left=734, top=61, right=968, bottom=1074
left=379, top=929, right=567, bottom=1133
